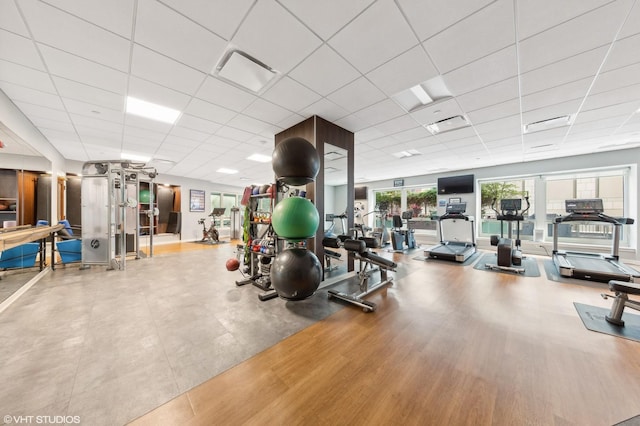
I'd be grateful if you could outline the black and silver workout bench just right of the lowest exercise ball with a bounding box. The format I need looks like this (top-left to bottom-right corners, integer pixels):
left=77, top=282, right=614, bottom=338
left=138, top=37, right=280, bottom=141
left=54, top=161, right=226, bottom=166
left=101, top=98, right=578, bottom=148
left=322, top=238, right=398, bottom=312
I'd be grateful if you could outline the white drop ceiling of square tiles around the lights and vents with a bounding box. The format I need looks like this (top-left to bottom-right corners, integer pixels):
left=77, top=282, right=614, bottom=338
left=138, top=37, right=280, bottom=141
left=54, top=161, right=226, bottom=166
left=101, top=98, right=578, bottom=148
left=0, top=0, right=640, bottom=186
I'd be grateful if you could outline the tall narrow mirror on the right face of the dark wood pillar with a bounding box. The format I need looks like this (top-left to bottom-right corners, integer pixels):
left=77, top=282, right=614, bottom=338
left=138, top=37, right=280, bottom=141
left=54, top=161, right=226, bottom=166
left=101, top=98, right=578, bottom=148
left=321, top=143, right=351, bottom=277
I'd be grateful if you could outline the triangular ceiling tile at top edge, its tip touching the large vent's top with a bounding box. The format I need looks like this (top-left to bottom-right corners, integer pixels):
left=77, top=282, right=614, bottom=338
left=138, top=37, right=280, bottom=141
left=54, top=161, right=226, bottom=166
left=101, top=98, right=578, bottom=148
left=158, top=0, right=254, bottom=40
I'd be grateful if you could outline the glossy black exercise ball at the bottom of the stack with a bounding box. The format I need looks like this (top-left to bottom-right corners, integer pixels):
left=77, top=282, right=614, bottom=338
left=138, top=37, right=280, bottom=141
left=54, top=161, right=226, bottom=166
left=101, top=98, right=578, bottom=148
left=270, top=248, right=322, bottom=300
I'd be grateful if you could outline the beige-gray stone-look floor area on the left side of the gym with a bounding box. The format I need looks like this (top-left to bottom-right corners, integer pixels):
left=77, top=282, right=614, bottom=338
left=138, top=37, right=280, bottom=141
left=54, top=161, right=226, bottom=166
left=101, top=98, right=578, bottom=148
left=0, top=243, right=356, bottom=425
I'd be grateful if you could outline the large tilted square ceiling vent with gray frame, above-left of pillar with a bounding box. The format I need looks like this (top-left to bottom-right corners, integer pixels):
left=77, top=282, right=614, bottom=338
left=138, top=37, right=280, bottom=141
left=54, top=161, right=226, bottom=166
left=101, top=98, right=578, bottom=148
left=217, top=49, right=276, bottom=93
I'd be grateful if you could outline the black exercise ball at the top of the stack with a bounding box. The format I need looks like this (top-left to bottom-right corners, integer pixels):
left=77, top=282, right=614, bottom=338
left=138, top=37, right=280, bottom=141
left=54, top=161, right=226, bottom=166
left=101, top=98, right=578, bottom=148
left=271, top=137, right=320, bottom=186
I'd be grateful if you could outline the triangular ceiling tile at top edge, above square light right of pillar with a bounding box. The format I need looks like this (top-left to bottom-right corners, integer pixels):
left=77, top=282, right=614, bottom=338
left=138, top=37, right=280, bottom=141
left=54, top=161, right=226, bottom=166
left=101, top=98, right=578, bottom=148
left=398, top=0, right=495, bottom=41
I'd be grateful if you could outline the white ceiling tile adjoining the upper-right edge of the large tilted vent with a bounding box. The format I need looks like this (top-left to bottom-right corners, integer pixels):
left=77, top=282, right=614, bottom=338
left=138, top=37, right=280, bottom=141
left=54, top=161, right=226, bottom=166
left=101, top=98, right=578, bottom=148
left=232, top=0, right=322, bottom=73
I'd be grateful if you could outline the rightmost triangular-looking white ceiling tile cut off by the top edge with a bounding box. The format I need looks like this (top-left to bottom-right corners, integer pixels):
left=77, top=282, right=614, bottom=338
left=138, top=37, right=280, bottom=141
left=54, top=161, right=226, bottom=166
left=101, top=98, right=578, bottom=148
left=517, top=0, right=610, bottom=39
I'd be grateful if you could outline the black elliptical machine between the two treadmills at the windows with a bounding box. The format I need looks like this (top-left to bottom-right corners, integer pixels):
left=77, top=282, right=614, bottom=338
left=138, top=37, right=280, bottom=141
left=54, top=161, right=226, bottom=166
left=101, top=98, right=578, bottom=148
left=485, top=196, right=530, bottom=273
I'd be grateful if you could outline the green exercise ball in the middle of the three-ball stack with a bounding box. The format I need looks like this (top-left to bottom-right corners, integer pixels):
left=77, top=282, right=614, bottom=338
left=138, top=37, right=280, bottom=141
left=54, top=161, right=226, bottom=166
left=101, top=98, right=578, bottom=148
left=271, top=197, right=320, bottom=240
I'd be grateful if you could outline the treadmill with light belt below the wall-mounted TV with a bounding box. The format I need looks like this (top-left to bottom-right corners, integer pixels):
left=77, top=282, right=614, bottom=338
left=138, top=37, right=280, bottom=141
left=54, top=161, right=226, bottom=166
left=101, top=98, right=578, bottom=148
left=424, top=203, right=476, bottom=262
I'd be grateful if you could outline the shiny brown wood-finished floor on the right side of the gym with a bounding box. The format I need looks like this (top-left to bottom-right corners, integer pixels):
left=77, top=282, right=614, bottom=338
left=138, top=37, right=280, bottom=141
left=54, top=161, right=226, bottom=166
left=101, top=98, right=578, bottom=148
left=132, top=244, right=640, bottom=426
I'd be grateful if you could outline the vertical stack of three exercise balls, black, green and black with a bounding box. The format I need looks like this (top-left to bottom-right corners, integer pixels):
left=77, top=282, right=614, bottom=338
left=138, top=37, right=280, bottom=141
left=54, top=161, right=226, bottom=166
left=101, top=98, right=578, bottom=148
left=270, top=137, right=322, bottom=300
